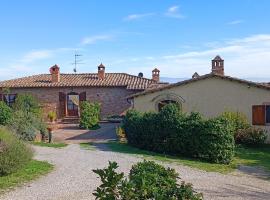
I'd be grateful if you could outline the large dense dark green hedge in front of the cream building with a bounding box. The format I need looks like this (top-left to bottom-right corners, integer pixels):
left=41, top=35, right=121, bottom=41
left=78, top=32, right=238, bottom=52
left=123, top=104, right=235, bottom=163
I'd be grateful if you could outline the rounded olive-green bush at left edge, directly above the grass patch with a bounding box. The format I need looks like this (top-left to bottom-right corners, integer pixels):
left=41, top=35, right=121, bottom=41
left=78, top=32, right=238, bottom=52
left=0, top=128, right=33, bottom=176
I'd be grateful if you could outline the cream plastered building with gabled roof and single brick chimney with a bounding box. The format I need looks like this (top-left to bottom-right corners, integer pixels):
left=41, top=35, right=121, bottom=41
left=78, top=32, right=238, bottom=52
left=128, top=56, right=270, bottom=141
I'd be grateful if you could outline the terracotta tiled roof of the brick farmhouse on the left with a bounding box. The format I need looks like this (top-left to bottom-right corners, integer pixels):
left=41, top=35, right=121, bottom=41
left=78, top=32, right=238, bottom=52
left=0, top=73, right=168, bottom=90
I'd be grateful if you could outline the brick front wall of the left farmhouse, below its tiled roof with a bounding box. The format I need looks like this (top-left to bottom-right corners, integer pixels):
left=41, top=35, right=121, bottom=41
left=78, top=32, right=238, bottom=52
left=3, top=87, right=138, bottom=118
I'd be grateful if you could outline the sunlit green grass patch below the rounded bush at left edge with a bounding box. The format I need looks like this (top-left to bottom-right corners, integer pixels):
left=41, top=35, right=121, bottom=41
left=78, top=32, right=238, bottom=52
left=0, top=160, right=53, bottom=193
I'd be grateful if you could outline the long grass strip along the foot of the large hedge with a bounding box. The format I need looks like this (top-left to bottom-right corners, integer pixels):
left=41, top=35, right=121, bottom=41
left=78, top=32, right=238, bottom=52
left=107, top=142, right=270, bottom=174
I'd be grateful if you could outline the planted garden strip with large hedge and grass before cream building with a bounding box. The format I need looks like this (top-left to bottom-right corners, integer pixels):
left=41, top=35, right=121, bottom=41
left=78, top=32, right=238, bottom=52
left=119, top=104, right=270, bottom=172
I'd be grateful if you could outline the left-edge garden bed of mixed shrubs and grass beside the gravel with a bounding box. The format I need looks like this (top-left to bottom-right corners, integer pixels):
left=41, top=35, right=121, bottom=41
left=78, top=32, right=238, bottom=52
left=0, top=94, right=53, bottom=192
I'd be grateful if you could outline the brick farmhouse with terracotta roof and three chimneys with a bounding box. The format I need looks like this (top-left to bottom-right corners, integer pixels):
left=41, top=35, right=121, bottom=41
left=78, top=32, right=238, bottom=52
left=0, top=64, right=166, bottom=119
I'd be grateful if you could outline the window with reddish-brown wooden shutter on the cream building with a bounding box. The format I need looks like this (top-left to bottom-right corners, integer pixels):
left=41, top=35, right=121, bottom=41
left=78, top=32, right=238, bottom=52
left=252, top=105, right=270, bottom=125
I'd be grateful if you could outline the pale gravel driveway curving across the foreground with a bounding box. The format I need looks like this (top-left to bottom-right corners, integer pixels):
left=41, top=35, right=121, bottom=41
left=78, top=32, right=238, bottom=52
left=0, top=144, right=270, bottom=200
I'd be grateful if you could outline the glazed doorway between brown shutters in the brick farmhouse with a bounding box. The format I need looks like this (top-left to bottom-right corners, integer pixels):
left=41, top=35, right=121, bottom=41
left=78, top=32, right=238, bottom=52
left=67, top=92, right=80, bottom=117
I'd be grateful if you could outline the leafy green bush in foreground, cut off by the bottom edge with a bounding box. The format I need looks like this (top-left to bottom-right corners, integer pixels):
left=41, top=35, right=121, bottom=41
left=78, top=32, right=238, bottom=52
left=93, top=161, right=202, bottom=200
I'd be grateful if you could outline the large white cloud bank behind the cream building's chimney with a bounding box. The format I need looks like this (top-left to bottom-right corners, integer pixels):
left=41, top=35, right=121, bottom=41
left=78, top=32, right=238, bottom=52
left=146, top=34, right=270, bottom=78
